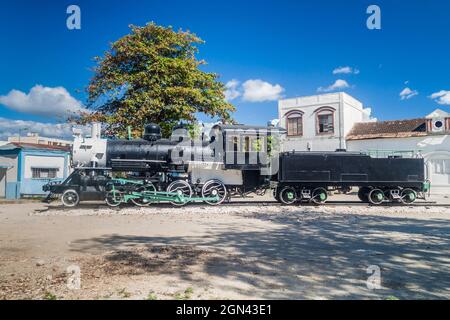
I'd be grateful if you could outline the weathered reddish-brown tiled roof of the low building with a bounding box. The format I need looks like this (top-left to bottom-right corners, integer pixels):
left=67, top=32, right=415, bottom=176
left=346, top=118, right=427, bottom=140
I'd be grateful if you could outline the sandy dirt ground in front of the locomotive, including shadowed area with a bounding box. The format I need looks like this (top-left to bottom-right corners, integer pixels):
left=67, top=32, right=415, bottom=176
left=0, top=195, right=450, bottom=299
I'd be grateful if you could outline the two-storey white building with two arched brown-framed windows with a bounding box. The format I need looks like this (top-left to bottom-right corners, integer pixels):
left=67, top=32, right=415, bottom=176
left=278, top=92, right=367, bottom=151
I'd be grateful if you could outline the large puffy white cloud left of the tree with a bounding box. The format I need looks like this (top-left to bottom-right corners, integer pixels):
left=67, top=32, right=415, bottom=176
left=0, top=85, right=85, bottom=118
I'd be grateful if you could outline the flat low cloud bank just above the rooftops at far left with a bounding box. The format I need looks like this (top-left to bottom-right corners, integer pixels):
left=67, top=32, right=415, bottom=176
left=0, top=117, right=89, bottom=140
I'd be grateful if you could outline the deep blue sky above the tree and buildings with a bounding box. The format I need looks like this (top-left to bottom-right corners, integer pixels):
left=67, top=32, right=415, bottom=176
left=0, top=0, right=450, bottom=136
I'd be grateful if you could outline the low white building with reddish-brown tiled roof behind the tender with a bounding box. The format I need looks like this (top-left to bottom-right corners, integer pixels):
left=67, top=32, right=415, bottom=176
left=347, top=109, right=450, bottom=194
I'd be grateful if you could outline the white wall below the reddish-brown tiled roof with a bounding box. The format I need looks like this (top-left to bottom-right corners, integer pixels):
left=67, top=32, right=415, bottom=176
left=347, top=135, right=450, bottom=194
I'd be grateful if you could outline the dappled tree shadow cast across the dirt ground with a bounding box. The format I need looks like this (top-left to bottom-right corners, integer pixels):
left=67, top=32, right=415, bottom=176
left=72, top=210, right=450, bottom=299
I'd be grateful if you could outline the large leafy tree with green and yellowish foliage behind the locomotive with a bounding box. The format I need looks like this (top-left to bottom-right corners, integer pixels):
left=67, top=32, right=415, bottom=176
left=81, top=23, right=235, bottom=136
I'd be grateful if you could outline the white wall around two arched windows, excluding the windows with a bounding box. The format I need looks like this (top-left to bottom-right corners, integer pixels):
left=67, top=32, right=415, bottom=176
left=278, top=92, right=363, bottom=151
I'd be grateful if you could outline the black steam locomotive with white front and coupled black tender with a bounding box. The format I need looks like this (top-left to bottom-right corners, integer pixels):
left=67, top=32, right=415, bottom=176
left=44, top=124, right=429, bottom=207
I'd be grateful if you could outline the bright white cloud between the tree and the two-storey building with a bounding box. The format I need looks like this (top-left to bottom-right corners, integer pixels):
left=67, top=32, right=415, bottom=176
left=242, top=79, right=284, bottom=102
